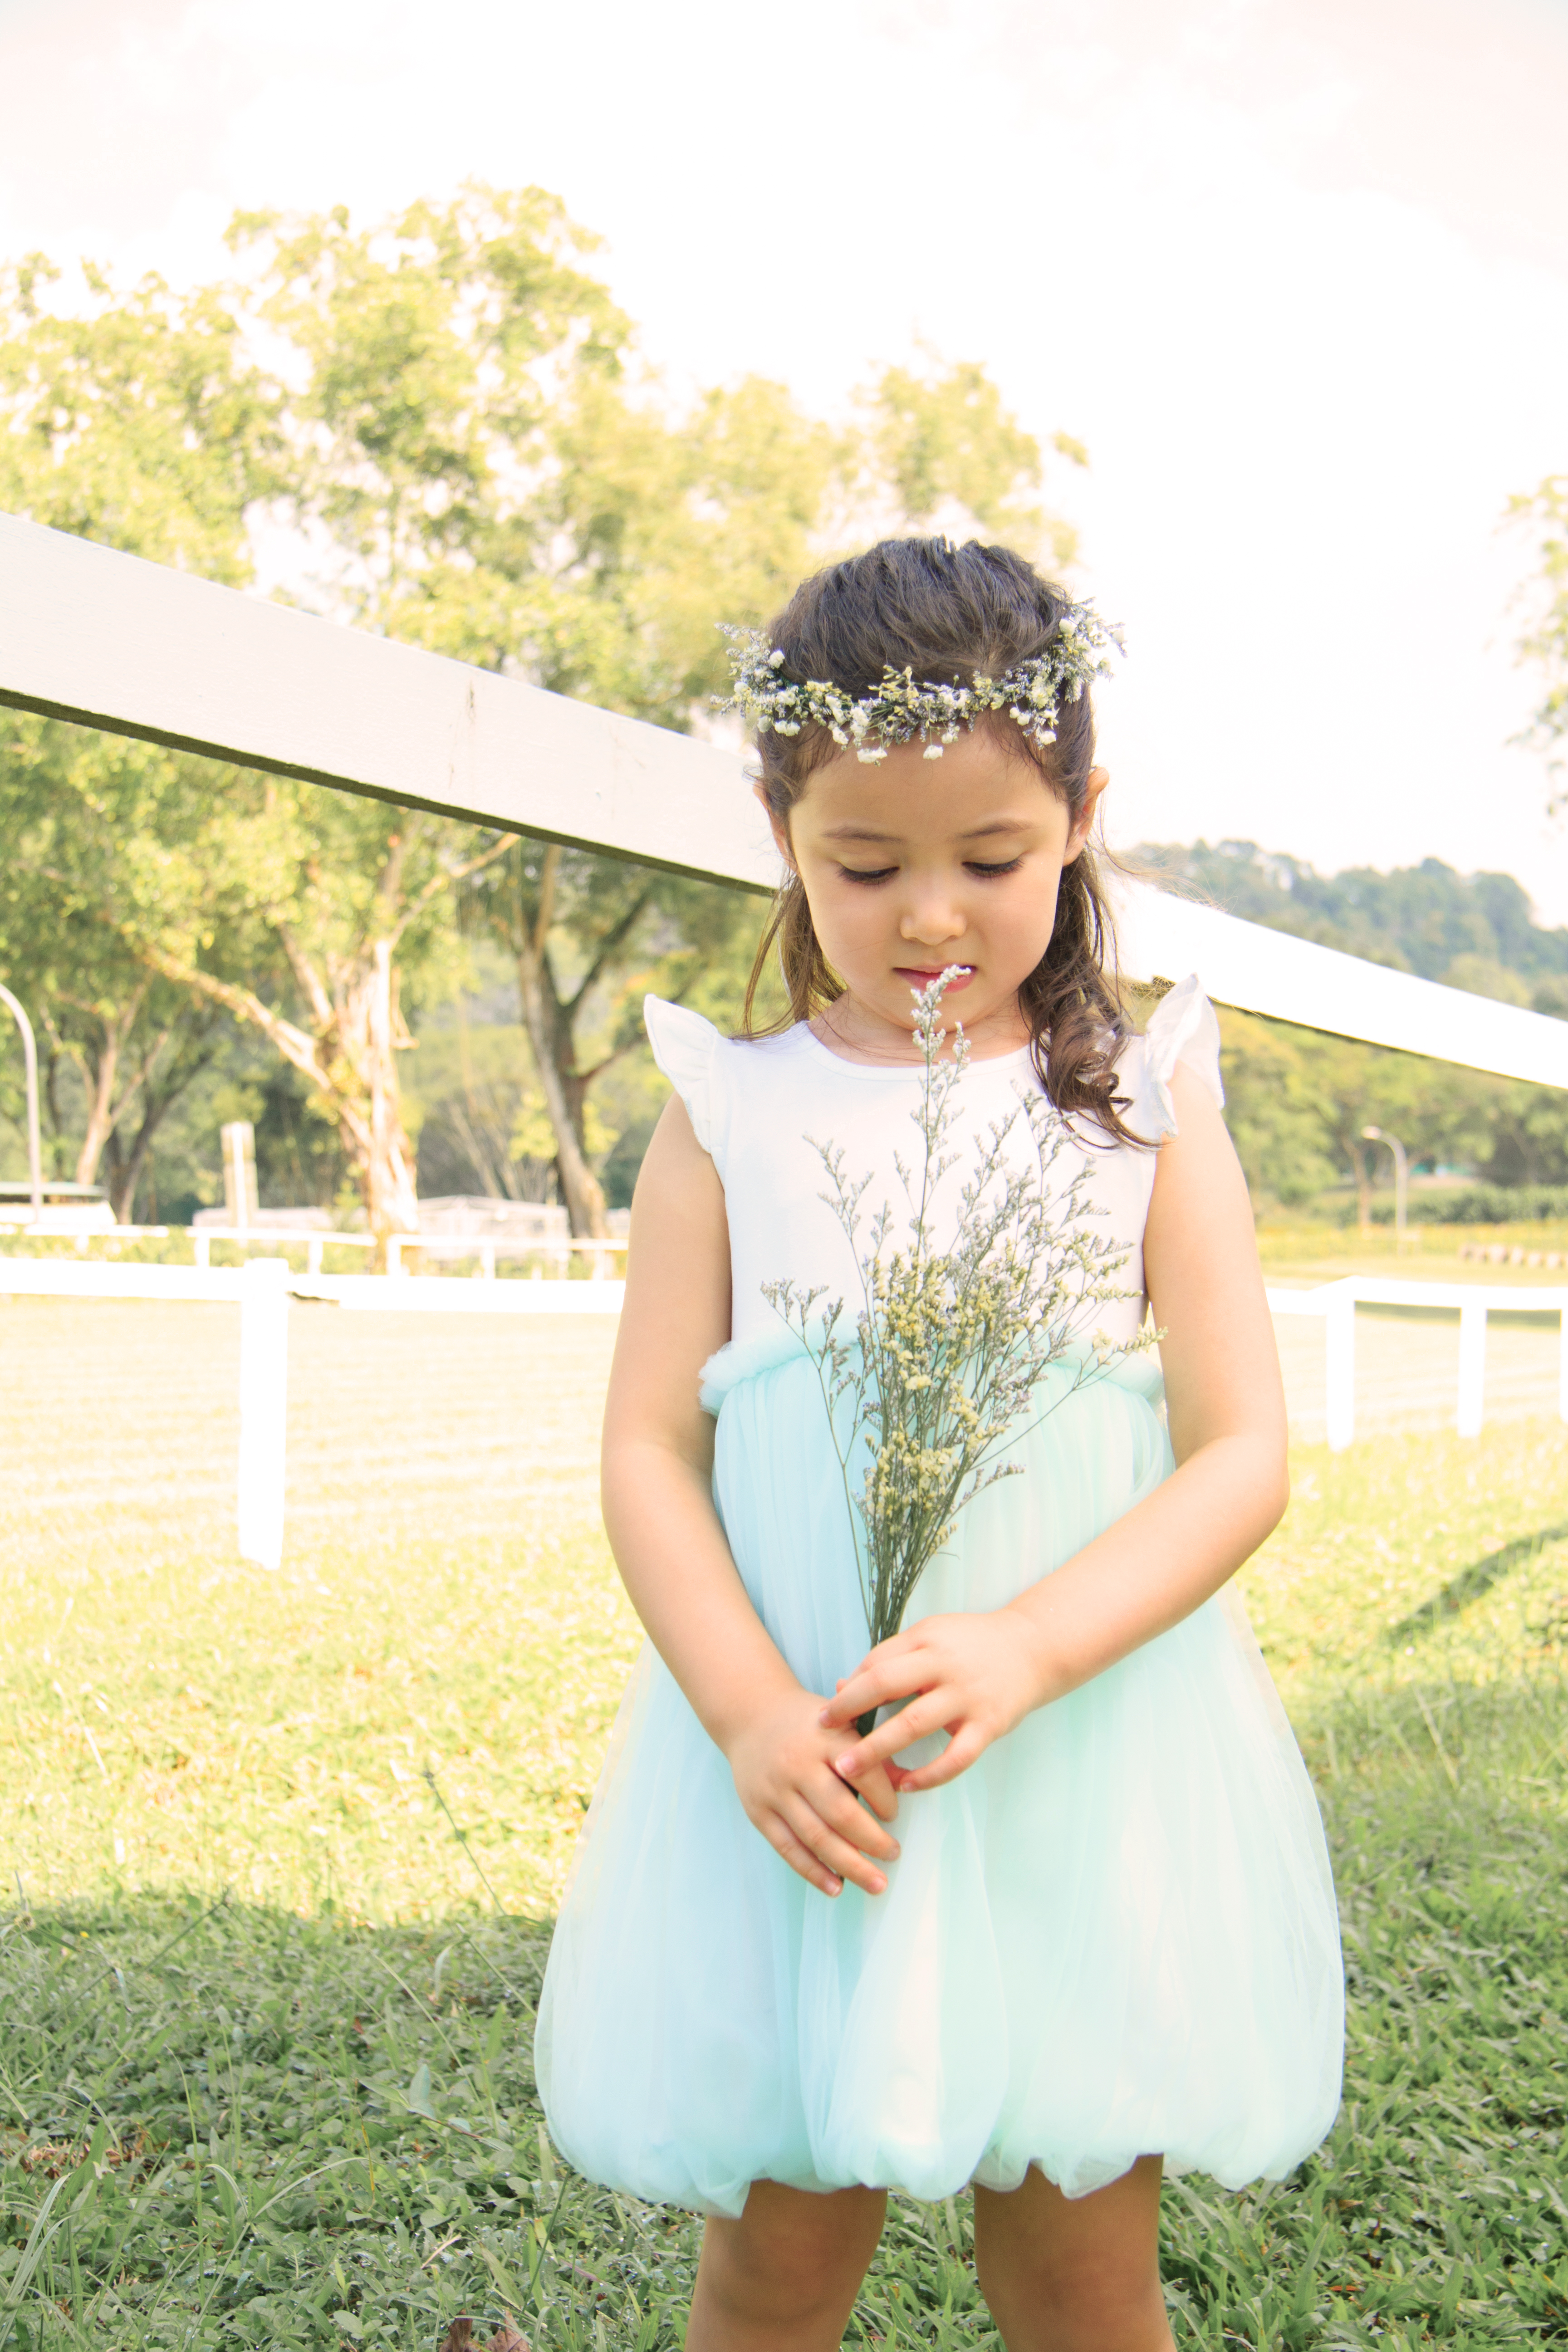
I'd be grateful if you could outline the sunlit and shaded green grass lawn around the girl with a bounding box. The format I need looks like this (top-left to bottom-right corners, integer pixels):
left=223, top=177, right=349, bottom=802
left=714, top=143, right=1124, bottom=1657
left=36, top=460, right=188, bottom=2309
left=0, top=1301, right=1568, bottom=2352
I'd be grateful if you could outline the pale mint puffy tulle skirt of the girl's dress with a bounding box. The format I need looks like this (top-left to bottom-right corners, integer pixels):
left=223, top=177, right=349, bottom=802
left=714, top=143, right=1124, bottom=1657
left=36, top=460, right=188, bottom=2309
left=536, top=1338, right=1343, bottom=2215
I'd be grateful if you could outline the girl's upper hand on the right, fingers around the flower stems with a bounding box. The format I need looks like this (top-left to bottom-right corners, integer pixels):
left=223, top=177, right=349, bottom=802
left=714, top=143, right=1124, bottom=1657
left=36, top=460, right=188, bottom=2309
left=820, top=1609, right=1055, bottom=1790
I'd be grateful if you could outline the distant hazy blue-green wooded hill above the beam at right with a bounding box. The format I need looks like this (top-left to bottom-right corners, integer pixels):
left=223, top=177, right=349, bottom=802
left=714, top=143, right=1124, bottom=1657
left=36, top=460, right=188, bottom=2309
left=1126, top=842, right=1568, bottom=1016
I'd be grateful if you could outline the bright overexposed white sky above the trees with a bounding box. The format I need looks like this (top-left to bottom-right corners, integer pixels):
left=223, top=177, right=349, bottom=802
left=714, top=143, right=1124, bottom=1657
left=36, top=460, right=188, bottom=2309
left=0, top=0, right=1568, bottom=922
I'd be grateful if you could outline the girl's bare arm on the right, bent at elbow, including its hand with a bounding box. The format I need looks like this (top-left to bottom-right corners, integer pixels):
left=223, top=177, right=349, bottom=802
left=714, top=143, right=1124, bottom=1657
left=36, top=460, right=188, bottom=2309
left=823, top=1068, right=1291, bottom=1788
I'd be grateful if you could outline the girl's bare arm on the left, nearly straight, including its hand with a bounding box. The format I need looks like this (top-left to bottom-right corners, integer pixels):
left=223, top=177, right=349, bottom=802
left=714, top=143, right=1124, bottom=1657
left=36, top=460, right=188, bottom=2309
left=602, top=1101, right=898, bottom=1893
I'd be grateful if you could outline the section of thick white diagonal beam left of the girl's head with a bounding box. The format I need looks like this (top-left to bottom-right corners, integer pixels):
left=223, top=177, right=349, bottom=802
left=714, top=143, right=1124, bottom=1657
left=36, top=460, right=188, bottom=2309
left=0, top=515, right=778, bottom=892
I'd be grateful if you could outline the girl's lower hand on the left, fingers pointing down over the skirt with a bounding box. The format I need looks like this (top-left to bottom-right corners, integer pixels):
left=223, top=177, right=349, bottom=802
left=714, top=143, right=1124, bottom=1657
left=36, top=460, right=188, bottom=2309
left=724, top=1689, right=898, bottom=1896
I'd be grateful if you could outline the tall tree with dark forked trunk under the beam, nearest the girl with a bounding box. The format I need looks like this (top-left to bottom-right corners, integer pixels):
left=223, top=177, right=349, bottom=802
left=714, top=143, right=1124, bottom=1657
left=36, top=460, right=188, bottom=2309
left=235, top=186, right=1081, bottom=1235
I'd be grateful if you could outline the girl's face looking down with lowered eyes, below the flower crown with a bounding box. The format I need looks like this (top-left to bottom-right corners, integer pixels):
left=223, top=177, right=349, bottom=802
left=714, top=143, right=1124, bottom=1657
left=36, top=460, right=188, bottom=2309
left=774, top=729, right=1107, bottom=1061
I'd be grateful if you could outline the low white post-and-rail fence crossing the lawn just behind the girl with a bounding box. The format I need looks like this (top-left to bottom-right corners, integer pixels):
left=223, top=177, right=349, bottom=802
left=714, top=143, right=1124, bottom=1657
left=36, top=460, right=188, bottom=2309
left=0, top=1256, right=1568, bottom=1569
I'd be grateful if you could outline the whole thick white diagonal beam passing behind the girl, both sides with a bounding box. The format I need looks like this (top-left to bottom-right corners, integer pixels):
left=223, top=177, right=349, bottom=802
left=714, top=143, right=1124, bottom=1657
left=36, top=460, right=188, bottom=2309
left=0, top=515, right=1568, bottom=1087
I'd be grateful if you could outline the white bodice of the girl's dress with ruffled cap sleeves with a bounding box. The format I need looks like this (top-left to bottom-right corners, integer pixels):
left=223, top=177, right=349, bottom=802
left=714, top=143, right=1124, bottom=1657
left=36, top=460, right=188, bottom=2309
left=644, top=976, right=1225, bottom=1343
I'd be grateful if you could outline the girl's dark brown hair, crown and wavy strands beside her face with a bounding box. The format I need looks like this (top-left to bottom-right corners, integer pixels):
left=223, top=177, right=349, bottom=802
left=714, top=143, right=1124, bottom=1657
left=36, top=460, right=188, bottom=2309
left=743, top=539, right=1142, bottom=1143
